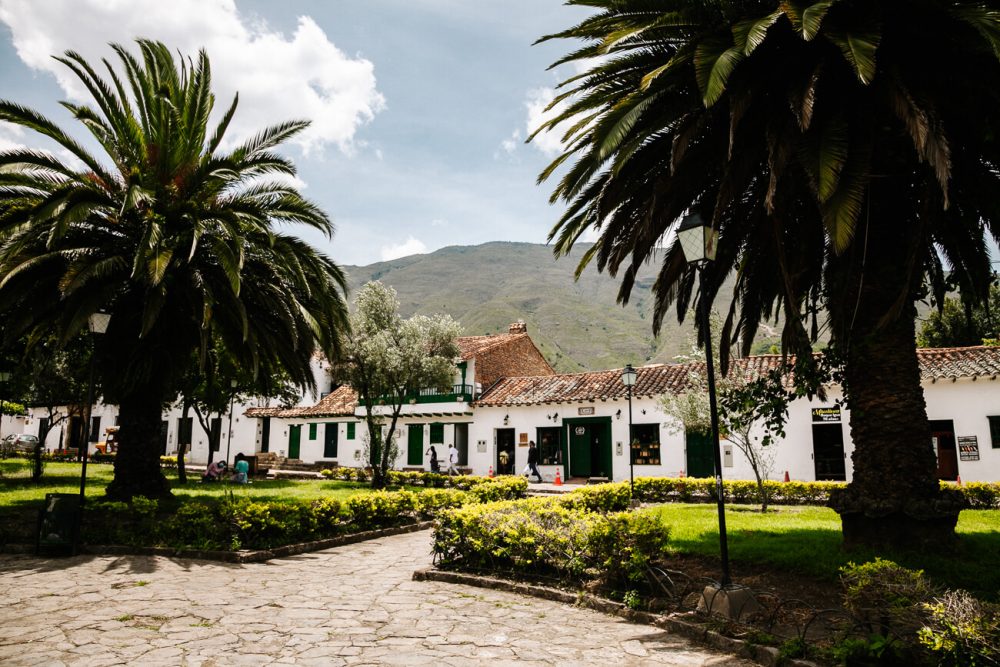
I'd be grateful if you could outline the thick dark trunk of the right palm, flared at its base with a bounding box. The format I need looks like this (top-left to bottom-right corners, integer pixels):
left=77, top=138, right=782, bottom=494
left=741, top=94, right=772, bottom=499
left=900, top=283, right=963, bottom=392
left=830, top=219, right=962, bottom=548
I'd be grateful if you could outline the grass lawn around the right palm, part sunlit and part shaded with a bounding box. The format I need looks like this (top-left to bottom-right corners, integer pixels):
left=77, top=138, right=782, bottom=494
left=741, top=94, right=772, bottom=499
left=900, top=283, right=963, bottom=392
left=649, top=504, right=1000, bottom=600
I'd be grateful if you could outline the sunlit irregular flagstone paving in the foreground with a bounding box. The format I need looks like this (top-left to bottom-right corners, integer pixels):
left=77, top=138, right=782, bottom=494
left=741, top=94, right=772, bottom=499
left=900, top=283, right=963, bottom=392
left=0, top=531, right=750, bottom=667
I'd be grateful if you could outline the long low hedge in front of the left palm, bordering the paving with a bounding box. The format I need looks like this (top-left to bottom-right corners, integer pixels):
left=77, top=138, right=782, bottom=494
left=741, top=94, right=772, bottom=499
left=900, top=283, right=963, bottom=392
left=84, top=479, right=527, bottom=551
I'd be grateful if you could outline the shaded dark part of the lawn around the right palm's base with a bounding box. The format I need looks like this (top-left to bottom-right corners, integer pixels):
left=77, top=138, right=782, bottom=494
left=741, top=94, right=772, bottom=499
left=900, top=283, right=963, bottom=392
left=670, top=528, right=1000, bottom=601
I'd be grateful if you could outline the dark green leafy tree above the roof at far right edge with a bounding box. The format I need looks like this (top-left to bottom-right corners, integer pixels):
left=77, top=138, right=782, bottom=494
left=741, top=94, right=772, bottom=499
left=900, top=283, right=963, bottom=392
left=917, top=283, right=1000, bottom=347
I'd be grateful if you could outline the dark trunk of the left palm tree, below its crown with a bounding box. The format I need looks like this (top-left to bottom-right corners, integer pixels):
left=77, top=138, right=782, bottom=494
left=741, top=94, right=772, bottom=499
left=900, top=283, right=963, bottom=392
left=106, top=387, right=171, bottom=501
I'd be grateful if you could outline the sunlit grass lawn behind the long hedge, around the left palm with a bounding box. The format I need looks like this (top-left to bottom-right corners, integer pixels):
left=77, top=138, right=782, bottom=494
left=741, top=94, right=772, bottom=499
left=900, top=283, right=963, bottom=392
left=0, top=459, right=369, bottom=512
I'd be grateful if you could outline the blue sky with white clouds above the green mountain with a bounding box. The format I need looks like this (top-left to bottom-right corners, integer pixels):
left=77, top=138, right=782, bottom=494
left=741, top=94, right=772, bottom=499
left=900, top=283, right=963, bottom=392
left=0, top=0, right=585, bottom=264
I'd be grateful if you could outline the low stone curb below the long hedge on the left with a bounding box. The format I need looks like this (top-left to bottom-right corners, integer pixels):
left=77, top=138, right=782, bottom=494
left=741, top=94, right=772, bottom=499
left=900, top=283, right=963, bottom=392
left=0, top=521, right=434, bottom=564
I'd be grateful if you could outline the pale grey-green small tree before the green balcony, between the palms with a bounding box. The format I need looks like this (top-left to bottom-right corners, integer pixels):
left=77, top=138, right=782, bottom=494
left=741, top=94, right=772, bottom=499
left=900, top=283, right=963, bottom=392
left=339, top=281, right=461, bottom=488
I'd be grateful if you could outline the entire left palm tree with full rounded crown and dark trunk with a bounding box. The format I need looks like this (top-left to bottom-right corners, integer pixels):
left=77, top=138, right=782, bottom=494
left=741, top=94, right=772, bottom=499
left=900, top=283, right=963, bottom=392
left=0, top=40, right=347, bottom=498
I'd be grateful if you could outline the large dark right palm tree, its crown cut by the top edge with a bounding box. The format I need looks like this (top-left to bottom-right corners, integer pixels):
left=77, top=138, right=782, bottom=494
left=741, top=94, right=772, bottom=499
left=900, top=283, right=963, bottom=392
left=540, top=0, right=1000, bottom=544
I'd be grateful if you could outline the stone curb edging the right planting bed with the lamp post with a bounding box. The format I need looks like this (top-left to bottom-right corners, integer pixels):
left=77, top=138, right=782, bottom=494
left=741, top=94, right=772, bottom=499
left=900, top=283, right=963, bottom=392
left=413, top=568, right=818, bottom=667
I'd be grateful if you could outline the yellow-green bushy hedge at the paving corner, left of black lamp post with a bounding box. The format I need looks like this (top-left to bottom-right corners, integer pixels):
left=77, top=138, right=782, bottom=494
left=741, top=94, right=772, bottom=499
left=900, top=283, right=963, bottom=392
left=434, top=494, right=669, bottom=582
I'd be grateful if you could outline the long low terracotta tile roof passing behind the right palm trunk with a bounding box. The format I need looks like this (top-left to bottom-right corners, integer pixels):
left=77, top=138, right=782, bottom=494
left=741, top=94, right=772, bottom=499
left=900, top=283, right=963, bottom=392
left=474, top=346, right=1000, bottom=406
